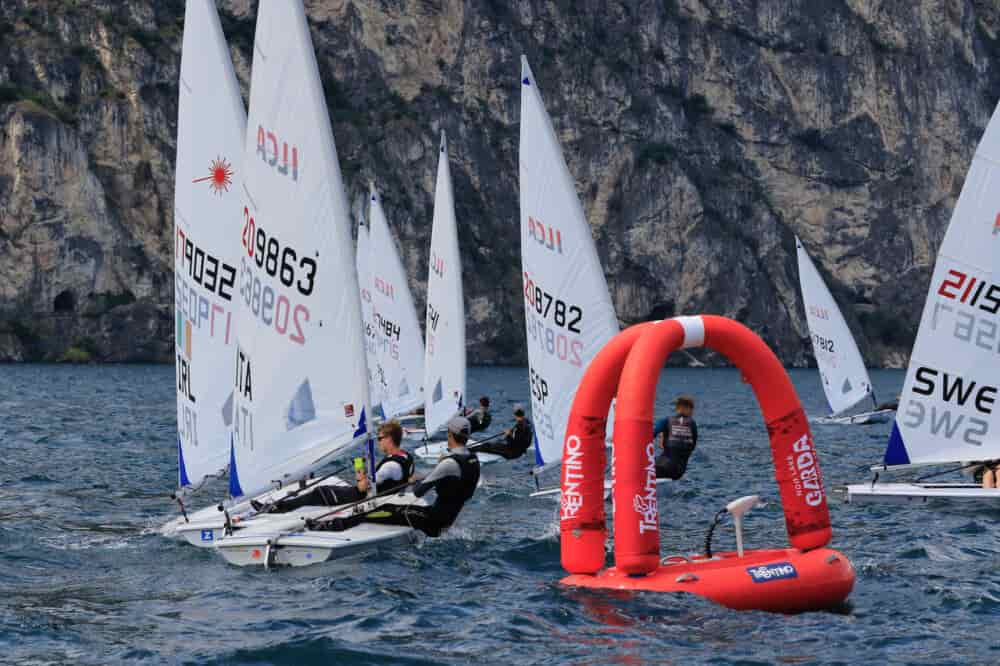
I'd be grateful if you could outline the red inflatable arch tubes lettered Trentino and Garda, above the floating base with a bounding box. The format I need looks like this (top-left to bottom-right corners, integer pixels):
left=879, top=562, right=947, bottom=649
left=560, top=315, right=854, bottom=610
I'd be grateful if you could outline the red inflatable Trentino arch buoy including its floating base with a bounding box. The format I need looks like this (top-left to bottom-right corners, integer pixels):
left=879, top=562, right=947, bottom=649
left=559, top=315, right=854, bottom=612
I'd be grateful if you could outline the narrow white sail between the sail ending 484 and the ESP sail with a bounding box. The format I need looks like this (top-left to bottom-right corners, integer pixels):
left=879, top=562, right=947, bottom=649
left=424, top=131, right=465, bottom=433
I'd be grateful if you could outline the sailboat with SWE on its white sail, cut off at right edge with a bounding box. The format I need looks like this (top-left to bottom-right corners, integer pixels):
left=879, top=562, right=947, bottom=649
left=847, top=100, right=1000, bottom=503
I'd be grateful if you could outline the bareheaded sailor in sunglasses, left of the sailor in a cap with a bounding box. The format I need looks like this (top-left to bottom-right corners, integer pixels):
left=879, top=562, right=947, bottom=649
left=258, top=421, right=413, bottom=513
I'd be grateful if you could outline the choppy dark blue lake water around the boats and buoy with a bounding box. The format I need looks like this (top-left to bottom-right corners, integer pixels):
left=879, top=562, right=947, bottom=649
left=0, top=366, right=1000, bottom=664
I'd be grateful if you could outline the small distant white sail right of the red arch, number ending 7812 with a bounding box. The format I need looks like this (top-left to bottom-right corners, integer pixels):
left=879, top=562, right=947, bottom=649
left=795, top=238, right=873, bottom=414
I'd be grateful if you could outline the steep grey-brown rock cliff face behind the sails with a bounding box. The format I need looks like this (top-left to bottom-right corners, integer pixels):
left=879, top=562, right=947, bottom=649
left=0, top=0, right=1000, bottom=366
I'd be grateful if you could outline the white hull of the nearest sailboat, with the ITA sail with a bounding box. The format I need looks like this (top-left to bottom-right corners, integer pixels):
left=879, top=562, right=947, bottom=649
left=215, top=493, right=427, bottom=567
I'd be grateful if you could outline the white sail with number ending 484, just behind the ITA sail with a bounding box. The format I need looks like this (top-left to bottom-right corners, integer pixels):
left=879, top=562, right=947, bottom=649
left=368, top=185, right=424, bottom=418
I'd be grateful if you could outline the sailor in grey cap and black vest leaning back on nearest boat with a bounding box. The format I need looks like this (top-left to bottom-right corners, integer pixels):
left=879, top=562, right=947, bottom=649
left=316, top=416, right=479, bottom=537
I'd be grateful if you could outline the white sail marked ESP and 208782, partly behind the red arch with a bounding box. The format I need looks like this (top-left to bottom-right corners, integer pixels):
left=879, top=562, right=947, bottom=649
left=520, top=56, right=618, bottom=467
